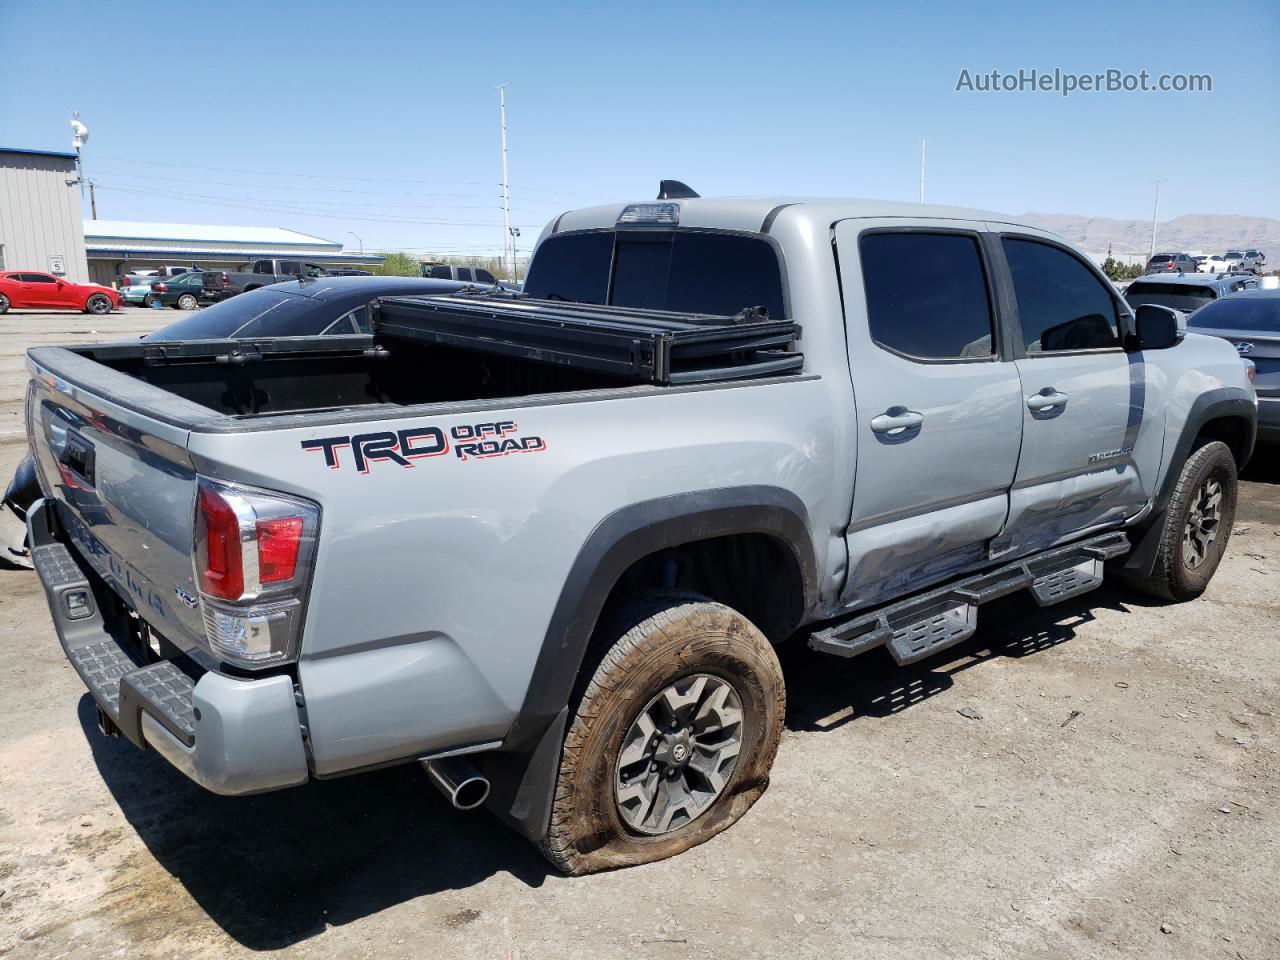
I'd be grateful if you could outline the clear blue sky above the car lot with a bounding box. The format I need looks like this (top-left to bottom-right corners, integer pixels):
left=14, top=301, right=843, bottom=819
left=0, top=0, right=1280, bottom=253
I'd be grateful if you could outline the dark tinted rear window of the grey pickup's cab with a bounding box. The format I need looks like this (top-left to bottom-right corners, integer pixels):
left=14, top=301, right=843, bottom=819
left=525, top=230, right=787, bottom=320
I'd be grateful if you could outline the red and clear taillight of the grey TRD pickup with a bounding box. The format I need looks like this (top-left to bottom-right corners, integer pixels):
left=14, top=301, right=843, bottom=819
left=193, top=477, right=320, bottom=668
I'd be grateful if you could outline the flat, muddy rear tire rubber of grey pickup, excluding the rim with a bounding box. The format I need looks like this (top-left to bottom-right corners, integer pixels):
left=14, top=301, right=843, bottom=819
left=539, top=593, right=786, bottom=874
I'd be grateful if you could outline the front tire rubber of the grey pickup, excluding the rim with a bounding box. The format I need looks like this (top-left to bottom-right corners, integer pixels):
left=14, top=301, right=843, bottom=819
left=1125, top=440, right=1239, bottom=600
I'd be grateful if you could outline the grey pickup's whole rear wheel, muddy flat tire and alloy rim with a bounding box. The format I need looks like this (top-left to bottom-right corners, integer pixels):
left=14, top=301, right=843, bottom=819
left=540, top=594, right=786, bottom=874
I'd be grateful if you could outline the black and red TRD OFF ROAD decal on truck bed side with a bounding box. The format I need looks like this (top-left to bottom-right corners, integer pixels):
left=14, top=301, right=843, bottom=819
left=302, top=420, right=547, bottom=474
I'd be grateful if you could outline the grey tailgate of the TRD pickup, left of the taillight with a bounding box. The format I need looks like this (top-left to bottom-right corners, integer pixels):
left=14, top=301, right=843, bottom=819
left=27, top=348, right=212, bottom=650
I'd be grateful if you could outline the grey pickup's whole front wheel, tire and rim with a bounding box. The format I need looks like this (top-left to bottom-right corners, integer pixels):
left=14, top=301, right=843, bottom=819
left=1128, top=440, right=1238, bottom=600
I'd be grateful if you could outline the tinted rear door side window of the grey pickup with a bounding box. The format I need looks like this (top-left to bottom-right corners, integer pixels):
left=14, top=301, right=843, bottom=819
left=858, top=233, right=993, bottom=360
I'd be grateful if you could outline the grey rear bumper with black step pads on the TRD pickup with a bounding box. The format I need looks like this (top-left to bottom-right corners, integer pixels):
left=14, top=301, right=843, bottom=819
left=27, top=499, right=308, bottom=795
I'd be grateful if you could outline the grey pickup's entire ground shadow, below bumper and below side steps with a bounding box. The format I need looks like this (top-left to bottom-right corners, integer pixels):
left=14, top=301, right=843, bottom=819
left=79, top=578, right=1162, bottom=950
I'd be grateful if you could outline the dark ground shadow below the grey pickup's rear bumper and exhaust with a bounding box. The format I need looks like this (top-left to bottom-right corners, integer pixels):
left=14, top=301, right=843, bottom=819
left=79, top=695, right=550, bottom=950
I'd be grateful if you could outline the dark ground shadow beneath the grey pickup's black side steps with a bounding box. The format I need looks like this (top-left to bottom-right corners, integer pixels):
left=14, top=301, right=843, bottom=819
left=782, top=585, right=1157, bottom=731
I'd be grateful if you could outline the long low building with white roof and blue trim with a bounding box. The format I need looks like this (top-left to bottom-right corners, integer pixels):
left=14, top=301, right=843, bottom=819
left=84, top=220, right=383, bottom=283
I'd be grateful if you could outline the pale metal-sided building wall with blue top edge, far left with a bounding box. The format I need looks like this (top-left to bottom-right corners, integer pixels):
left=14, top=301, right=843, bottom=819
left=0, top=151, right=90, bottom=283
